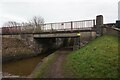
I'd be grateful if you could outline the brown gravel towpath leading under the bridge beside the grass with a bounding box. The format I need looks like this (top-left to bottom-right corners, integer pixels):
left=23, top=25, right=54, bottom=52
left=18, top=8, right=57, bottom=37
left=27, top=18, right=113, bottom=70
left=48, top=48, right=71, bottom=78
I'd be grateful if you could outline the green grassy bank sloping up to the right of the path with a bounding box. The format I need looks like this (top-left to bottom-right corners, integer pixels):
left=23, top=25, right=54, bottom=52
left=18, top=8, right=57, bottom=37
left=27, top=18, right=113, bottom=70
left=63, top=35, right=118, bottom=78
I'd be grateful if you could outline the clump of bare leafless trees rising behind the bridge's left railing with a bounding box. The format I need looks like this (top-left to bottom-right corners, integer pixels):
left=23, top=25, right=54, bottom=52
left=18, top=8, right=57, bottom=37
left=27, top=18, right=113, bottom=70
left=3, top=16, right=44, bottom=32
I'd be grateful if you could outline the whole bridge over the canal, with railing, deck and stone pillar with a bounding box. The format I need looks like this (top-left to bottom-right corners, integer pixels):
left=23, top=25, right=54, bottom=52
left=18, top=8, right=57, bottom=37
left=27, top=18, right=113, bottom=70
left=2, top=15, right=103, bottom=50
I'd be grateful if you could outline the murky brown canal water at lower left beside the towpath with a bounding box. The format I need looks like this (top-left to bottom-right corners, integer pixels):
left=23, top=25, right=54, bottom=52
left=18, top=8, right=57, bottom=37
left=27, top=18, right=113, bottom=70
left=2, top=53, right=49, bottom=76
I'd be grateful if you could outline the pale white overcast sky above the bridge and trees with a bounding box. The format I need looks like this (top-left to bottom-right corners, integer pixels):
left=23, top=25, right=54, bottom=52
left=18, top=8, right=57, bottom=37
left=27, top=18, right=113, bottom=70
left=0, top=0, right=119, bottom=26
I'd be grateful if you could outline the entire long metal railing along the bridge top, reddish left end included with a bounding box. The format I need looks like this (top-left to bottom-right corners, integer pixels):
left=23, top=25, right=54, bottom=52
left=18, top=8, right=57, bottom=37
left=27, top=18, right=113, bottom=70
left=2, top=19, right=95, bottom=34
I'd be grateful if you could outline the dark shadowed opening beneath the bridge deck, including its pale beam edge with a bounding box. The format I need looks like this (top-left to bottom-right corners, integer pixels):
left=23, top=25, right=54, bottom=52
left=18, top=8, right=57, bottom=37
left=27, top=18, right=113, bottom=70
left=33, top=32, right=80, bottom=49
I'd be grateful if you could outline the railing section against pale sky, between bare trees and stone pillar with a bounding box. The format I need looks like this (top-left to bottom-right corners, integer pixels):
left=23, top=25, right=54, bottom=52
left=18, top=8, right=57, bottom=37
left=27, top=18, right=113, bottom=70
left=42, top=20, right=95, bottom=31
